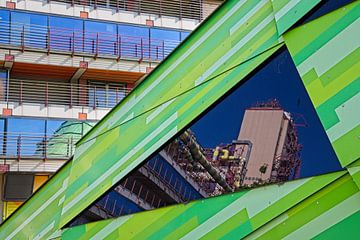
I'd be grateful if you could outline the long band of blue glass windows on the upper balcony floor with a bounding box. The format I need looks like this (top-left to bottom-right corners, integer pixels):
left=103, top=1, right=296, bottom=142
left=0, top=10, right=189, bottom=61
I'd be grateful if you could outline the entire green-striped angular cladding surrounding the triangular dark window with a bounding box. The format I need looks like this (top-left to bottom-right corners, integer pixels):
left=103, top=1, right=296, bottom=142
left=0, top=0, right=360, bottom=239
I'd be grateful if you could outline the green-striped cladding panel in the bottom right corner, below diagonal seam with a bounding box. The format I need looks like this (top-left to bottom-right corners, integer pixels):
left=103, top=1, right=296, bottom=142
left=245, top=174, right=360, bottom=240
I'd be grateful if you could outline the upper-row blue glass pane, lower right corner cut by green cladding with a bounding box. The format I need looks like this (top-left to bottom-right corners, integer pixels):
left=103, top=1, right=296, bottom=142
left=150, top=28, right=180, bottom=60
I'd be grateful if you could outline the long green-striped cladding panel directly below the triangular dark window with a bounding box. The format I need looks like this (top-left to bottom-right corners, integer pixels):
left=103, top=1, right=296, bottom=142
left=62, top=171, right=346, bottom=239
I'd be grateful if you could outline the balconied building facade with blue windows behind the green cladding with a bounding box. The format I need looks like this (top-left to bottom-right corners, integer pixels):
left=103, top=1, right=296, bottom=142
left=0, top=0, right=221, bottom=222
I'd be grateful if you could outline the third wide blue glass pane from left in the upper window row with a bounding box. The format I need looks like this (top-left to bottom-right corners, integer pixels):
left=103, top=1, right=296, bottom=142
left=84, top=21, right=118, bottom=55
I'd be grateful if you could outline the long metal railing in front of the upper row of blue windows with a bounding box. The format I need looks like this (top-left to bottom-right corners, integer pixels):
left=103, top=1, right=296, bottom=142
left=0, top=21, right=180, bottom=62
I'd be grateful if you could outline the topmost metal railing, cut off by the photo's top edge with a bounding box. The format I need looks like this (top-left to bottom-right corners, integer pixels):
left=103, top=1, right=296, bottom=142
left=43, top=0, right=203, bottom=21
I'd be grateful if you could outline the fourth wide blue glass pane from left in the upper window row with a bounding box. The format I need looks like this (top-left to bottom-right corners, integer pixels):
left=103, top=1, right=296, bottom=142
left=118, top=25, right=149, bottom=59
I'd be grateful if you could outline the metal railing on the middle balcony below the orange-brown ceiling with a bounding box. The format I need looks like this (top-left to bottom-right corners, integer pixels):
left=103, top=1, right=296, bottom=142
left=4, top=79, right=131, bottom=109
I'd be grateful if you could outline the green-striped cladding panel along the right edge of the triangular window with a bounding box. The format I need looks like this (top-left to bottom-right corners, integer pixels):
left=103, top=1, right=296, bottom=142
left=284, top=1, right=360, bottom=166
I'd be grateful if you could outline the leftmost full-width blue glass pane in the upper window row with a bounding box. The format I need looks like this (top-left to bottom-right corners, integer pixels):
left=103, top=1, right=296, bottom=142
left=11, top=12, right=48, bottom=48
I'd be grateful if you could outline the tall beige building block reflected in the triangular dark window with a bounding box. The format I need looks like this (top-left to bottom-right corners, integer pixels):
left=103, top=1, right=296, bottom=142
left=238, top=101, right=301, bottom=186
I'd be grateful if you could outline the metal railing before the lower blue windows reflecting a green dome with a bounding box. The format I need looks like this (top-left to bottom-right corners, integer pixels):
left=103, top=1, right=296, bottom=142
left=0, top=132, right=81, bottom=160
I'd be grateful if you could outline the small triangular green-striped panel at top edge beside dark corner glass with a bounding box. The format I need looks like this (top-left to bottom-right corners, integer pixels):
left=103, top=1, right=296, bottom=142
left=272, top=0, right=321, bottom=35
